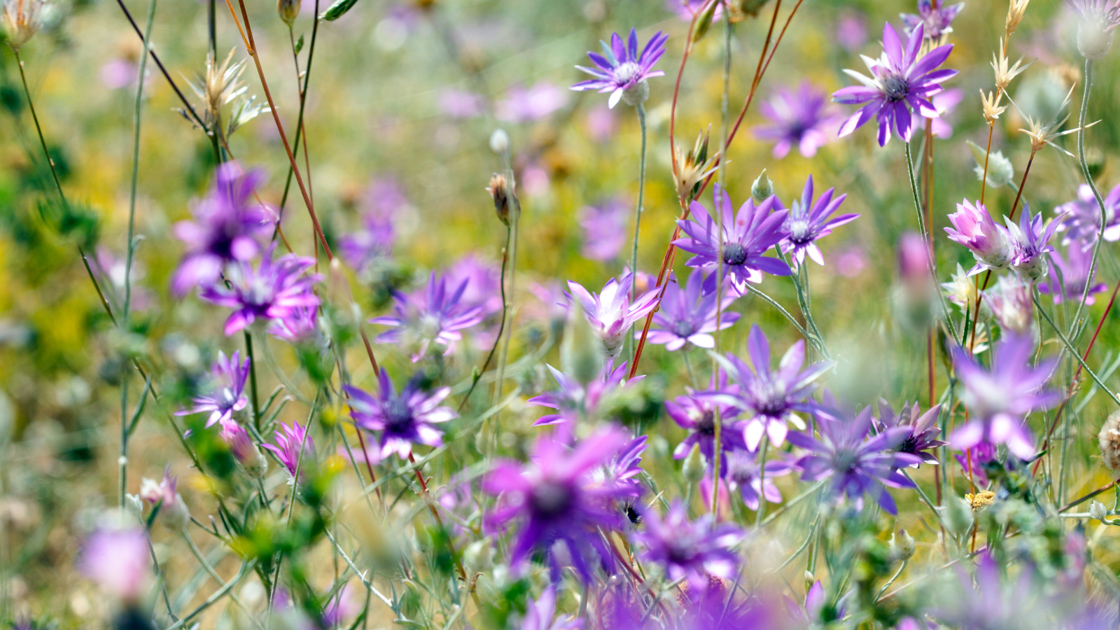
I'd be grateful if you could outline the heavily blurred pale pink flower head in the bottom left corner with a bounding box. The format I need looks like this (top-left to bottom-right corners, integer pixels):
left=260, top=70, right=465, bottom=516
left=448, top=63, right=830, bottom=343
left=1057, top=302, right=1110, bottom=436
left=77, top=528, right=151, bottom=604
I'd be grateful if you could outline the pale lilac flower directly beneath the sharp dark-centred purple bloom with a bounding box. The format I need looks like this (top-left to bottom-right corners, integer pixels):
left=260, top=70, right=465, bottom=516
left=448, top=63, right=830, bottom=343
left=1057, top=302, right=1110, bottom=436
left=635, top=269, right=741, bottom=352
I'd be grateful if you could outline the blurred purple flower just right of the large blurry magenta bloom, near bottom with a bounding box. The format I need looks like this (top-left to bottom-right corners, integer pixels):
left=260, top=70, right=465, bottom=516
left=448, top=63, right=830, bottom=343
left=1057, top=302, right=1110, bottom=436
left=636, top=501, right=743, bottom=592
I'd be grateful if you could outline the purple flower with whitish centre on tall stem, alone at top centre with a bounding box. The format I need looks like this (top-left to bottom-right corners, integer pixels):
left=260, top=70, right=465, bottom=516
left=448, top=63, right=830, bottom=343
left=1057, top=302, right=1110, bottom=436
left=571, top=28, right=669, bottom=109
